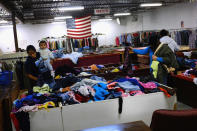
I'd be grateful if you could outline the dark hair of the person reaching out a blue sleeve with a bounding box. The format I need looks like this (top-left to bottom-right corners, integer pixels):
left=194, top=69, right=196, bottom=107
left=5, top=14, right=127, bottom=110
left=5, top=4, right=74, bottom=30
left=149, top=34, right=159, bottom=52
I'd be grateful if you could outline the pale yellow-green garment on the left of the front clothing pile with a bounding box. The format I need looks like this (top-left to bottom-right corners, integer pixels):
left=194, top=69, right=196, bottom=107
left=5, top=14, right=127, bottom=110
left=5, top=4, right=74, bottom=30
left=33, top=84, right=51, bottom=94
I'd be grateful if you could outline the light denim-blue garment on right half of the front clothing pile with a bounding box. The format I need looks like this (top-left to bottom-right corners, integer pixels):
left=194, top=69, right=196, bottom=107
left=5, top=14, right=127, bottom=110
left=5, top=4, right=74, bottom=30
left=117, top=81, right=140, bottom=91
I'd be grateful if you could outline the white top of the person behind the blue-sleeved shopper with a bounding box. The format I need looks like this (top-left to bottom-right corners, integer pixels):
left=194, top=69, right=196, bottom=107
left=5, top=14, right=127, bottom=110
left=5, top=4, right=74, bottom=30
left=160, top=36, right=180, bottom=52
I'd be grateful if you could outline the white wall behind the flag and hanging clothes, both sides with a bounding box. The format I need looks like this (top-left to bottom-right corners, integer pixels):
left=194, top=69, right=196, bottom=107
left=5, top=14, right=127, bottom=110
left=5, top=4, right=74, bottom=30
left=0, top=2, right=197, bottom=52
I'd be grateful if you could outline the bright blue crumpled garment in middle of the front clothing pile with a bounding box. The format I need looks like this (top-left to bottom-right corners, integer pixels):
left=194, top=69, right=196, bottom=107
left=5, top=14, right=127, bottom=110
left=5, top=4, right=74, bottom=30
left=92, top=83, right=109, bottom=101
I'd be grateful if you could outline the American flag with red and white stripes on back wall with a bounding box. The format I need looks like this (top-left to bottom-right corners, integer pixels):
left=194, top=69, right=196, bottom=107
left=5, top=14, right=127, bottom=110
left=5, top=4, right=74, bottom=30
left=66, top=16, right=92, bottom=39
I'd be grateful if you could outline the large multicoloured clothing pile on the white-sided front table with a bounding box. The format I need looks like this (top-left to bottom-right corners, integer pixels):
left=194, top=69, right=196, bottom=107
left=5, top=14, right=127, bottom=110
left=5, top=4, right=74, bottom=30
left=10, top=64, right=173, bottom=131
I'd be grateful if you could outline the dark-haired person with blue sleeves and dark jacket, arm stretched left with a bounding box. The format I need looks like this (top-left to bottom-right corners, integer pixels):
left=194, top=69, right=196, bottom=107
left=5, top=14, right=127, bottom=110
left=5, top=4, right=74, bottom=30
left=130, top=35, right=178, bottom=85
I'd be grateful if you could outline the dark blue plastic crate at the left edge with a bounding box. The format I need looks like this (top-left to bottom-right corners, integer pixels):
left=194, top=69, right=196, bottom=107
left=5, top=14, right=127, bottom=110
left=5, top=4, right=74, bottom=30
left=0, top=71, right=13, bottom=86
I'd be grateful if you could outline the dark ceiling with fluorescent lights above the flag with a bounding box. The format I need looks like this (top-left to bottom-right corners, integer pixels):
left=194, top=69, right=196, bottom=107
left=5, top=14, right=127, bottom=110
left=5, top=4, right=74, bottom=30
left=0, top=0, right=191, bottom=24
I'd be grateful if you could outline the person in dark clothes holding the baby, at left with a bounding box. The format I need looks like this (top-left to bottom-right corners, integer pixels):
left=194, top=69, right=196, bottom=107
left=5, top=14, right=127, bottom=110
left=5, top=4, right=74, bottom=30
left=25, top=45, right=40, bottom=94
